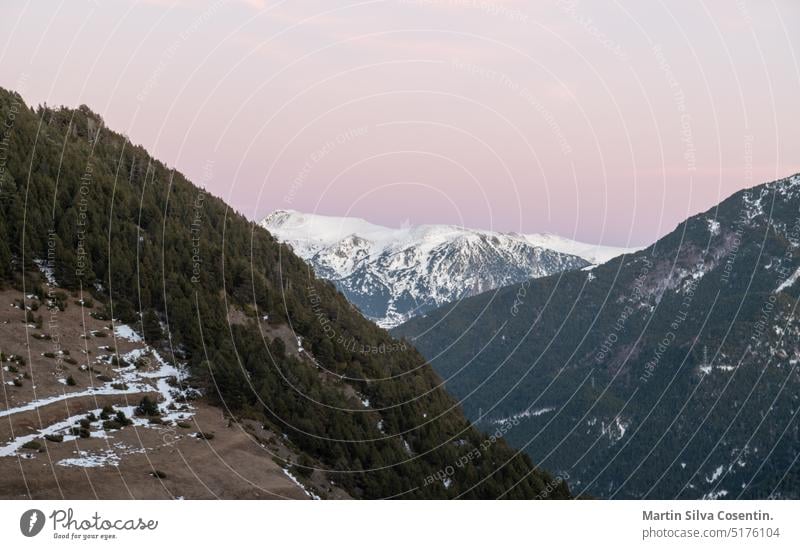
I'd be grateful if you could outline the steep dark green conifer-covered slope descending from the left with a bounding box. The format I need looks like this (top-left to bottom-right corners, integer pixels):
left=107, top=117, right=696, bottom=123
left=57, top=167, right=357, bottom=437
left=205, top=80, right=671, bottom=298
left=0, top=85, right=568, bottom=498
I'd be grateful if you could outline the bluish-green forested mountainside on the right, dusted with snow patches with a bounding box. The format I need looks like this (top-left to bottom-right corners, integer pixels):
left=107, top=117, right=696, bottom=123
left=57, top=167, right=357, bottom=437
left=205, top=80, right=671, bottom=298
left=394, top=176, right=800, bottom=499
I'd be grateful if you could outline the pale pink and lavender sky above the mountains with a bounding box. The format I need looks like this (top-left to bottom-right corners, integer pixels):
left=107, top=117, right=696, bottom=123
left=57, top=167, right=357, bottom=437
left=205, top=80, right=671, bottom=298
left=0, top=0, right=800, bottom=245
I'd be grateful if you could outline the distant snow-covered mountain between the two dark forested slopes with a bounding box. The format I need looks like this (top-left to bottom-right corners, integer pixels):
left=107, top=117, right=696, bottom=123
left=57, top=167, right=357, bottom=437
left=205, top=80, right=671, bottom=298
left=261, top=210, right=628, bottom=328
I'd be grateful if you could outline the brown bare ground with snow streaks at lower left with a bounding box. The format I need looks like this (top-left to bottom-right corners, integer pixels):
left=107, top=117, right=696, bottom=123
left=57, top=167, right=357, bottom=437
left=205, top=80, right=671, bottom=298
left=0, top=290, right=348, bottom=499
